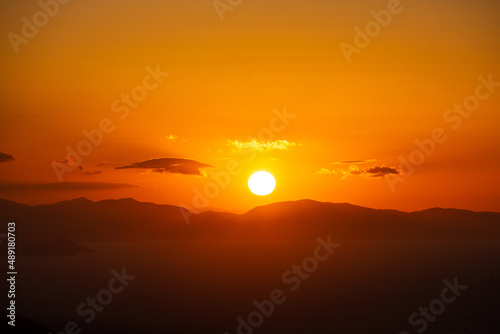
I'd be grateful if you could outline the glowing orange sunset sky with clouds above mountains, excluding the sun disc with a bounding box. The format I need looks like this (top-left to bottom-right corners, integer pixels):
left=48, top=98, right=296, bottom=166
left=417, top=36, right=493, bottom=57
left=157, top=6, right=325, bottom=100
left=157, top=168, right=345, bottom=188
left=0, top=0, right=500, bottom=212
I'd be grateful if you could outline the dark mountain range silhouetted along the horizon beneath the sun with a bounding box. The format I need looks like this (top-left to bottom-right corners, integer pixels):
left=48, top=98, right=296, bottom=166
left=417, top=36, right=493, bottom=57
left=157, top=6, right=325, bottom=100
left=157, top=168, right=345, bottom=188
left=0, top=198, right=500, bottom=242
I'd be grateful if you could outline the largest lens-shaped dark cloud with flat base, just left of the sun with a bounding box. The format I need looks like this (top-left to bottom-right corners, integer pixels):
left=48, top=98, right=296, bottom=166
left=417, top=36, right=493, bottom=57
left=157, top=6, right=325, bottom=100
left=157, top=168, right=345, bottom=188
left=115, top=158, right=214, bottom=176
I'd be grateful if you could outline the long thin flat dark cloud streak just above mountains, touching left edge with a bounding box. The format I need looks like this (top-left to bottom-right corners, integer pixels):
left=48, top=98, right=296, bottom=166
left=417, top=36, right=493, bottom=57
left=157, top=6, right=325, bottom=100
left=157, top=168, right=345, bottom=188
left=0, top=182, right=137, bottom=192
